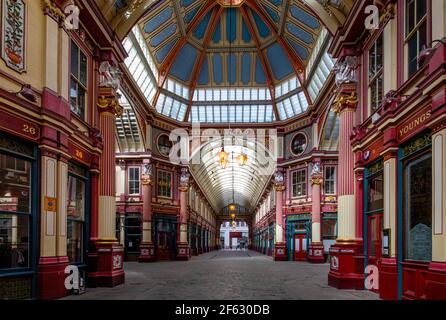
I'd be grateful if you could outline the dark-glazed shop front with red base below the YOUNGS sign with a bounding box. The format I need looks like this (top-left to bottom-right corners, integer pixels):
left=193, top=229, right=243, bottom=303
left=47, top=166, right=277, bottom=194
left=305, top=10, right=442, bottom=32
left=397, top=131, right=433, bottom=299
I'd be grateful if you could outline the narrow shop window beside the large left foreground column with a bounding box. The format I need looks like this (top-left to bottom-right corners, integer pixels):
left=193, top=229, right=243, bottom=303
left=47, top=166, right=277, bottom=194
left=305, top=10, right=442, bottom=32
left=67, top=165, right=86, bottom=263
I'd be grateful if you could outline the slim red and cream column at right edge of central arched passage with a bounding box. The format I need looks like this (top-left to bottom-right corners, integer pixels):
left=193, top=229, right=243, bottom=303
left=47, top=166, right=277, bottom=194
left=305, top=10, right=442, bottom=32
left=274, top=169, right=287, bottom=261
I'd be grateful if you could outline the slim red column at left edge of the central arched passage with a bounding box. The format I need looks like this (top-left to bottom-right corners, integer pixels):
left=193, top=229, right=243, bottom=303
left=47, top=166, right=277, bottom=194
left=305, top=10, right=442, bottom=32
left=177, top=168, right=190, bottom=260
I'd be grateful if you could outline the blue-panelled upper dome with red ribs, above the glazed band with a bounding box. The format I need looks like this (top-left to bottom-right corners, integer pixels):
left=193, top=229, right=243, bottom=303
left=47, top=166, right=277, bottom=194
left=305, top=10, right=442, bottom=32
left=140, top=0, right=321, bottom=88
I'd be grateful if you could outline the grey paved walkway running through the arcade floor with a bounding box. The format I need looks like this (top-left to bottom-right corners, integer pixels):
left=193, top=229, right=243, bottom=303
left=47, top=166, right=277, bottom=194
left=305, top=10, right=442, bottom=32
left=66, top=251, right=378, bottom=300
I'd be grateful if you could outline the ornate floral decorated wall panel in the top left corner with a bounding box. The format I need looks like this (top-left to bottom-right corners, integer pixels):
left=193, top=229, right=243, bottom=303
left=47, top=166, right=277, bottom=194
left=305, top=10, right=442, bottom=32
left=1, top=0, right=26, bottom=73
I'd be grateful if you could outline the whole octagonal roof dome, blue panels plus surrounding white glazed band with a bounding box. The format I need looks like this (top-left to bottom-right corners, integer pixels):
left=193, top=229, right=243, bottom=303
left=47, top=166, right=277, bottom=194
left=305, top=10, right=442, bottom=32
left=123, top=0, right=333, bottom=123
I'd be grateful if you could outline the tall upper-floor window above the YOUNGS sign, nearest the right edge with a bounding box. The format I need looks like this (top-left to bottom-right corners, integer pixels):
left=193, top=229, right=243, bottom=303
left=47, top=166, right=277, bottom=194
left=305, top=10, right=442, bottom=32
left=405, top=0, right=427, bottom=77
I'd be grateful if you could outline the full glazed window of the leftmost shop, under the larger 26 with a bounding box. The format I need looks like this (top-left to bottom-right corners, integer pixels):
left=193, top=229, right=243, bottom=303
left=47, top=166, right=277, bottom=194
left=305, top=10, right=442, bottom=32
left=0, top=154, right=31, bottom=271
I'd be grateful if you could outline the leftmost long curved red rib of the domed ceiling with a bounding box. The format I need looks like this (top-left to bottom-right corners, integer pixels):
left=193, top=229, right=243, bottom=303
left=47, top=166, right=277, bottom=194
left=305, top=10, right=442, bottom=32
left=152, top=0, right=218, bottom=107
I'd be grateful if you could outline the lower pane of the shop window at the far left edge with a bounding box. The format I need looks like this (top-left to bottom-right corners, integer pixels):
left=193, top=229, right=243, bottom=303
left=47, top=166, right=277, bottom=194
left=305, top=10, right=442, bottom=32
left=0, top=214, right=30, bottom=270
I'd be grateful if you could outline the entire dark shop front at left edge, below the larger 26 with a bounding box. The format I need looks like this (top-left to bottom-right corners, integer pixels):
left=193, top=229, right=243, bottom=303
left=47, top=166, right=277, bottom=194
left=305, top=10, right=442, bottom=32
left=0, top=131, right=39, bottom=299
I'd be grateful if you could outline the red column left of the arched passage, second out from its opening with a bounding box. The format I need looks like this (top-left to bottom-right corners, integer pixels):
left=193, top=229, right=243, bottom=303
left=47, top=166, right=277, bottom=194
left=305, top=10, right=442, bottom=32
left=138, top=159, right=156, bottom=262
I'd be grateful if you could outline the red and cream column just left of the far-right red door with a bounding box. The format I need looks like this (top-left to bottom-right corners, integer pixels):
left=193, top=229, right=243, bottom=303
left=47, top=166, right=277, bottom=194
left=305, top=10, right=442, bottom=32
left=308, top=159, right=325, bottom=263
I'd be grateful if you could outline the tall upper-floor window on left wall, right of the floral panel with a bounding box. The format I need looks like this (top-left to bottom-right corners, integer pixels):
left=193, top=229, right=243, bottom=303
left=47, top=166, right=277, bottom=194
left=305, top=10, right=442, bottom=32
left=70, top=41, right=88, bottom=120
